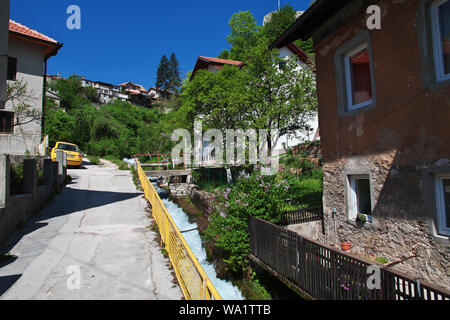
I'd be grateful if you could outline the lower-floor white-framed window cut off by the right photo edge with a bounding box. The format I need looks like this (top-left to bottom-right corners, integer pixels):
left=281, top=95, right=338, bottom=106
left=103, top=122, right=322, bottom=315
left=435, top=174, right=450, bottom=236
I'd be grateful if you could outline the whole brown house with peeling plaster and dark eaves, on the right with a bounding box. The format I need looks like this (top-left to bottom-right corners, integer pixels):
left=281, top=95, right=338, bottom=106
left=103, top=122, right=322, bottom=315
left=272, top=0, right=450, bottom=288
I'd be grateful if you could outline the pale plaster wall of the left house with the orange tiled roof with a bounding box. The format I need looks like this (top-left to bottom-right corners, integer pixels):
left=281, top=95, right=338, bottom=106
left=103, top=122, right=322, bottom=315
left=0, top=37, right=44, bottom=155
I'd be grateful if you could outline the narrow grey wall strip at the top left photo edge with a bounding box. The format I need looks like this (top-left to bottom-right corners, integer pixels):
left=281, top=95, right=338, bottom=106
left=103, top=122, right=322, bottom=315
left=0, top=0, right=9, bottom=109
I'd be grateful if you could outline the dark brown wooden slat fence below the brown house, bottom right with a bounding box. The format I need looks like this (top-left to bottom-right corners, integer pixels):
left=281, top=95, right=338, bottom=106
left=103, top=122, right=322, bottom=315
left=249, top=217, right=450, bottom=300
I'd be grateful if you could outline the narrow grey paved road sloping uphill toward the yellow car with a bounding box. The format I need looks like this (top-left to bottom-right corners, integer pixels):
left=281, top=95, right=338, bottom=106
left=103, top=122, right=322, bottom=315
left=0, top=163, right=182, bottom=300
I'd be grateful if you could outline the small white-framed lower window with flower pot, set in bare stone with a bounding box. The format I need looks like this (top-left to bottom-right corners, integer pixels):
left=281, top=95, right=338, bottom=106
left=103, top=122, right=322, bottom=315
left=348, top=175, right=372, bottom=222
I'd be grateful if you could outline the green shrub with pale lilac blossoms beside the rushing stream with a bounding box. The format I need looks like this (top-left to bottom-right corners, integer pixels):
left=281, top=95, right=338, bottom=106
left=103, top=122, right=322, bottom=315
left=205, top=171, right=289, bottom=272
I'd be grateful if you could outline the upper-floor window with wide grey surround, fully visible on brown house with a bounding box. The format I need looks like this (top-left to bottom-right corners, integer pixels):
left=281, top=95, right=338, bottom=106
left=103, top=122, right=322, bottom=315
left=335, top=31, right=376, bottom=116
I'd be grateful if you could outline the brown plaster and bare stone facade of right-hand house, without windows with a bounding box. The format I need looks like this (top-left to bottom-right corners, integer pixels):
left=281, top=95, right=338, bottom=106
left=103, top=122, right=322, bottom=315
left=315, top=0, right=450, bottom=288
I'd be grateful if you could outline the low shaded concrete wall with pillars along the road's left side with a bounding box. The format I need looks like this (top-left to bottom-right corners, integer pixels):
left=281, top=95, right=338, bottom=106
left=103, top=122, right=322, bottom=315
left=0, top=152, right=67, bottom=244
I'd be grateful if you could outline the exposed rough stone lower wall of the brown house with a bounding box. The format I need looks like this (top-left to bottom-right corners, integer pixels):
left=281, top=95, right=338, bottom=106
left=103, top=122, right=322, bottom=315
left=323, top=152, right=450, bottom=288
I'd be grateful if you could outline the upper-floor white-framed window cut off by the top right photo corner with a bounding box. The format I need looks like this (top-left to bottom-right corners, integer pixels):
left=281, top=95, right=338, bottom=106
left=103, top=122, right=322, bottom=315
left=430, top=0, right=450, bottom=82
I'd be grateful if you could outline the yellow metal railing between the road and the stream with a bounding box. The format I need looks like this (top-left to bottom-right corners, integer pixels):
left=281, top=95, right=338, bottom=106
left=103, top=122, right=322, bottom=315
left=136, top=159, right=222, bottom=300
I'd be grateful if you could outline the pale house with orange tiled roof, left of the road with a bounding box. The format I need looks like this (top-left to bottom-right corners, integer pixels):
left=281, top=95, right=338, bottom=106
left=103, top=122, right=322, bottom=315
left=0, top=20, right=62, bottom=155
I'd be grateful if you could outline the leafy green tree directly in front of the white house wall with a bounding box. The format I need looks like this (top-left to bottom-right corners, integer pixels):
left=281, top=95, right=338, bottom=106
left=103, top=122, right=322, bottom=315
left=243, top=43, right=317, bottom=149
